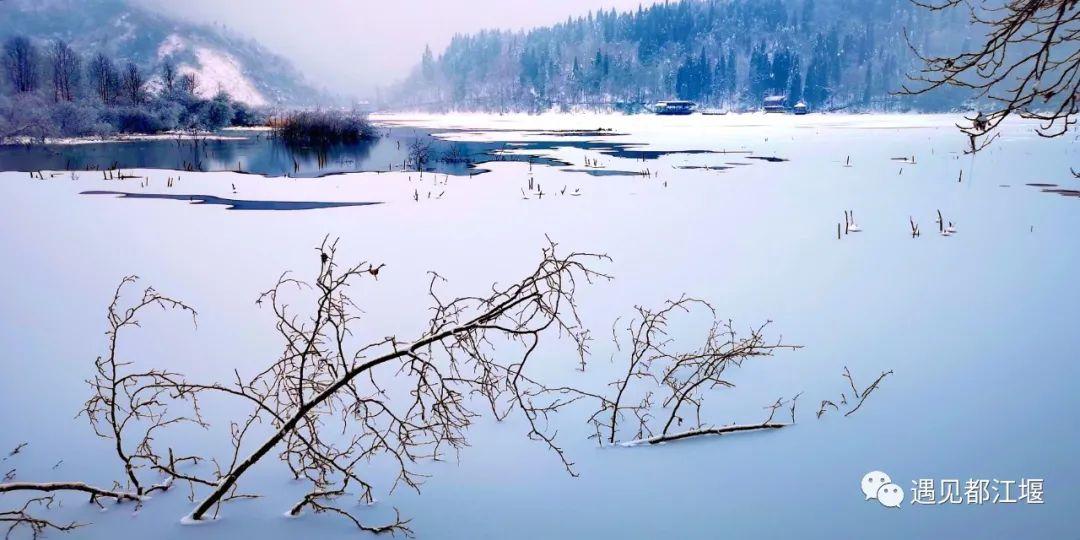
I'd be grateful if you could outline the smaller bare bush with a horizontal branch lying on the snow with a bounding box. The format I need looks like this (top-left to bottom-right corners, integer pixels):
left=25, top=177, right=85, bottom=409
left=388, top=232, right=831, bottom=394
left=590, top=296, right=799, bottom=444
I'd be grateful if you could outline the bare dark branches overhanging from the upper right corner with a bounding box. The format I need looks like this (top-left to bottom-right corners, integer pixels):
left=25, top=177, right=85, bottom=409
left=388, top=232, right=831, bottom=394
left=902, top=0, right=1080, bottom=152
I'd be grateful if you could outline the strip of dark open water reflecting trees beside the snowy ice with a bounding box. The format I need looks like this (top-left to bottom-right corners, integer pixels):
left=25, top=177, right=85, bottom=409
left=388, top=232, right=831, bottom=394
left=0, top=126, right=782, bottom=178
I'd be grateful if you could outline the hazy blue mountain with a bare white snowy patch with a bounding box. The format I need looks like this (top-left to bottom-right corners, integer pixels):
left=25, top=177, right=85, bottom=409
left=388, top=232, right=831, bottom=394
left=0, top=0, right=323, bottom=105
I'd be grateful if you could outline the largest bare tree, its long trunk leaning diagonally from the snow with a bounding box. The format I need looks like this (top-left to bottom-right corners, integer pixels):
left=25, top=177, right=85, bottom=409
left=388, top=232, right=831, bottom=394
left=0, top=241, right=607, bottom=535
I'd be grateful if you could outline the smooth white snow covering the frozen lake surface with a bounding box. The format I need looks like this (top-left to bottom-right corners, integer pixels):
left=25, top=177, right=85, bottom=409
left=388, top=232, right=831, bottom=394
left=0, top=114, right=1080, bottom=539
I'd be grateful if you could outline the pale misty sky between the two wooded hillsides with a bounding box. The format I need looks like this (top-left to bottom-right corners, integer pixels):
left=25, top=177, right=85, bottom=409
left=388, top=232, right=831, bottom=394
left=138, top=0, right=651, bottom=95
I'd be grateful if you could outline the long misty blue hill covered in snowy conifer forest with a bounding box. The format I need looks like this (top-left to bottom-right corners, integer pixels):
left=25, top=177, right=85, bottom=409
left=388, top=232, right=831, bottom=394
left=392, top=0, right=975, bottom=110
